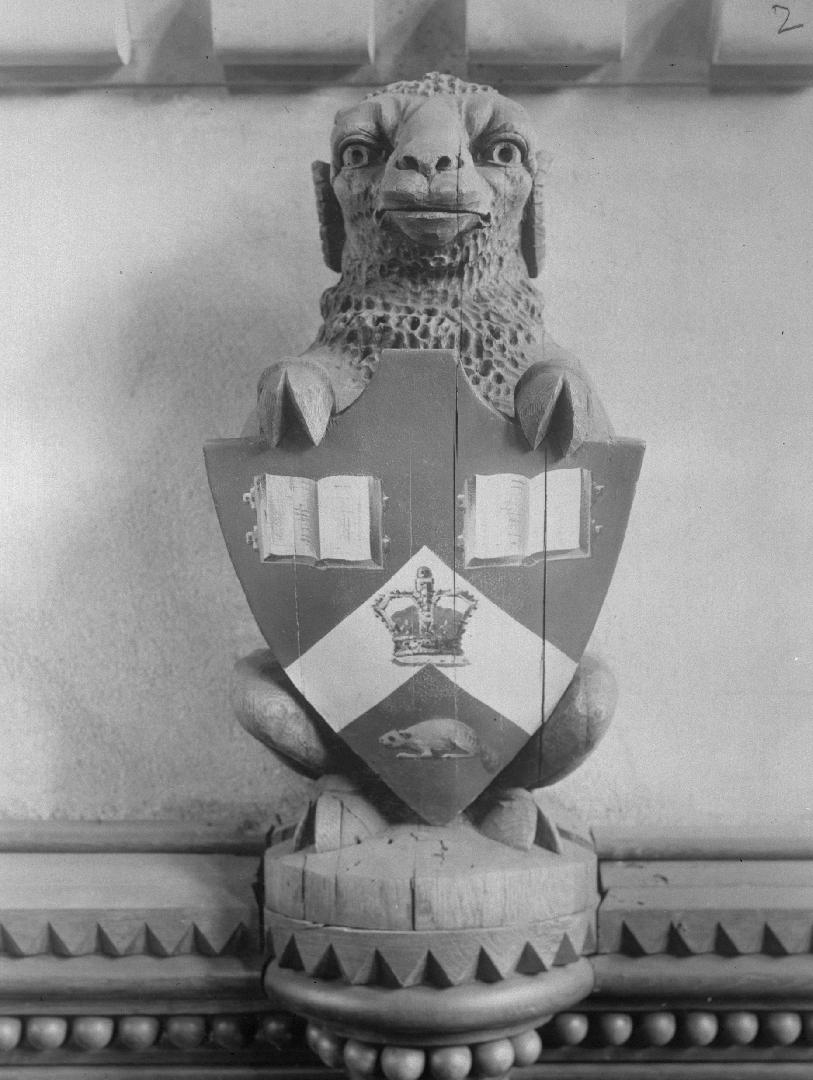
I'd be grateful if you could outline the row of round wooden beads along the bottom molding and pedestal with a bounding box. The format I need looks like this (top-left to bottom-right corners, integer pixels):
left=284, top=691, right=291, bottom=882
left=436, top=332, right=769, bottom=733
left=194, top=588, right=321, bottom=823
left=0, top=1008, right=813, bottom=1058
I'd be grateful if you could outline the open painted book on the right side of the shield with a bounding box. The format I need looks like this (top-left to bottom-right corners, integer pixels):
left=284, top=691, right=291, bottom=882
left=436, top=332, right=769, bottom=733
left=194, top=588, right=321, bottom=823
left=463, top=469, right=591, bottom=567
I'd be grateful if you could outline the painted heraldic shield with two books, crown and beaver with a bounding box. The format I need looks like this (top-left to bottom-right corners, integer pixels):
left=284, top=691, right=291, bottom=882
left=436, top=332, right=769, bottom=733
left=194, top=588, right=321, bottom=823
left=205, top=350, right=643, bottom=825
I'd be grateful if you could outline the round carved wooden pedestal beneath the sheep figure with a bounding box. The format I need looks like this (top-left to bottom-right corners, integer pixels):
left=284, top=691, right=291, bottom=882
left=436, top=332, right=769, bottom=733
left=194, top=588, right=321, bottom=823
left=263, top=821, right=598, bottom=1080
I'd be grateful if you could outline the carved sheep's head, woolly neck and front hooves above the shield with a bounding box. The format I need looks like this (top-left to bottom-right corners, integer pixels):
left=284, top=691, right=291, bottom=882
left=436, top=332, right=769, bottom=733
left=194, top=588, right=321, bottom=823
left=246, top=73, right=611, bottom=457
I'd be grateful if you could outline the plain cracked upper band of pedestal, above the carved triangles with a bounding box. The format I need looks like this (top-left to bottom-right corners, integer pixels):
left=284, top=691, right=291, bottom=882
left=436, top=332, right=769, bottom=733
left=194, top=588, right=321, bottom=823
left=265, top=826, right=596, bottom=931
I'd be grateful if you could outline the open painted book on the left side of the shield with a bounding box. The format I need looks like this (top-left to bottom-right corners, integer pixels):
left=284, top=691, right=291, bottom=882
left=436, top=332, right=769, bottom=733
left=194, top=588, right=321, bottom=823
left=244, top=473, right=382, bottom=569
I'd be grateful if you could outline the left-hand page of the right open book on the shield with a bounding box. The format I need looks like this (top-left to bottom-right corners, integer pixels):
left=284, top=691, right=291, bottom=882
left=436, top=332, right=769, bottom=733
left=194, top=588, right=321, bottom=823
left=466, top=473, right=528, bottom=558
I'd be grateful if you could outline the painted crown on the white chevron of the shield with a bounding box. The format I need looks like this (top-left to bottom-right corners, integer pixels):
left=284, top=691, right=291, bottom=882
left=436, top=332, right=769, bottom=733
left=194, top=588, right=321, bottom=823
left=372, top=566, right=477, bottom=665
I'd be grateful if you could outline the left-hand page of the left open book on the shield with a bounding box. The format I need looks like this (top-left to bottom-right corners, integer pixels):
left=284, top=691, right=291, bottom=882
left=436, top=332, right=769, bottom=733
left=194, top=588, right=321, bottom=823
left=257, top=473, right=319, bottom=559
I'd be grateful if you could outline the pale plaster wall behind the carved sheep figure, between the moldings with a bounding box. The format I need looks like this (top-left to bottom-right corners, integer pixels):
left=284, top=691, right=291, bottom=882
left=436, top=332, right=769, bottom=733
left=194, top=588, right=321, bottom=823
left=0, top=89, right=813, bottom=828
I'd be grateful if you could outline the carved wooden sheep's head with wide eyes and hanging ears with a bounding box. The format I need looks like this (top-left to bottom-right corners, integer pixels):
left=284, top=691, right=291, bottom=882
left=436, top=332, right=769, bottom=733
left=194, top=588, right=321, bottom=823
left=314, top=75, right=541, bottom=276
